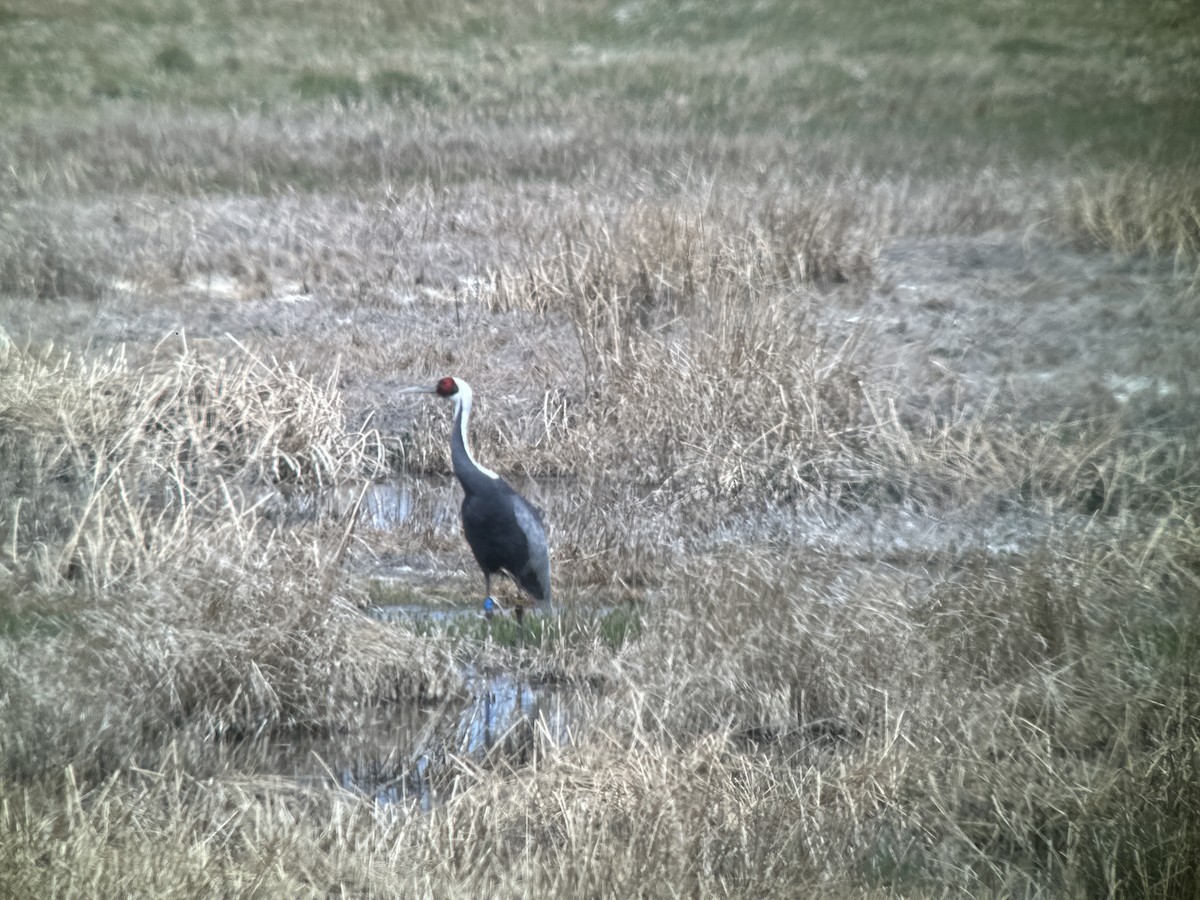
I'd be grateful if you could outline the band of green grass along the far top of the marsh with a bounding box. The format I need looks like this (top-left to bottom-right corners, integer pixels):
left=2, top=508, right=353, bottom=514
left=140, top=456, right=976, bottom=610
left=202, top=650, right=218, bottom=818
left=0, top=0, right=1200, bottom=167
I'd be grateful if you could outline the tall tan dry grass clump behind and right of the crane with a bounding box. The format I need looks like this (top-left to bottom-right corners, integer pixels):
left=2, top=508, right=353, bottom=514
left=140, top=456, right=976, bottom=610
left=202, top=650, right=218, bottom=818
left=482, top=195, right=871, bottom=499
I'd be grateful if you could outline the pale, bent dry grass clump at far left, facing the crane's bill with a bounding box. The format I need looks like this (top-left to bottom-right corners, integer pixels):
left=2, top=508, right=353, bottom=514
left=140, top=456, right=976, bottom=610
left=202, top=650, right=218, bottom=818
left=0, top=336, right=382, bottom=593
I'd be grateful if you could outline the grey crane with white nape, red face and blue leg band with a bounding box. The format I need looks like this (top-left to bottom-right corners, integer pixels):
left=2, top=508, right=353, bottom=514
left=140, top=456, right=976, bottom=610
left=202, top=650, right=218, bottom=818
left=401, top=376, right=551, bottom=622
